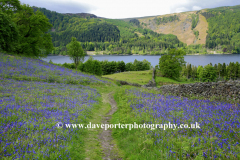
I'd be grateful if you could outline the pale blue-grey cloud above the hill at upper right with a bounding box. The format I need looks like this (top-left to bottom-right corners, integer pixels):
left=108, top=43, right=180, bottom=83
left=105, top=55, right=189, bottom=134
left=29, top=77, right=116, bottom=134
left=171, top=0, right=240, bottom=13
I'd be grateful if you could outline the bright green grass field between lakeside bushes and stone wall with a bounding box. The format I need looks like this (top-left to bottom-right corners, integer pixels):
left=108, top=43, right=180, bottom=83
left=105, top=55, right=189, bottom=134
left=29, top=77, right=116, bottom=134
left=103, top=70, right=152, bottom=85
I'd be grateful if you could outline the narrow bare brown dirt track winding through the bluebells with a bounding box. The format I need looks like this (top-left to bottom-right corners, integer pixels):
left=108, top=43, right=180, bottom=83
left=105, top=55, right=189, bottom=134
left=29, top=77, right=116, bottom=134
left=99, top=92, right=121, bottom=160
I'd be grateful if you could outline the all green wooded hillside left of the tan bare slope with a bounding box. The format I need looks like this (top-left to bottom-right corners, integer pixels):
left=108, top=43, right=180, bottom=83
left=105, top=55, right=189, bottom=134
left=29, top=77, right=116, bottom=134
left=33, top=7, right=184, bottom=55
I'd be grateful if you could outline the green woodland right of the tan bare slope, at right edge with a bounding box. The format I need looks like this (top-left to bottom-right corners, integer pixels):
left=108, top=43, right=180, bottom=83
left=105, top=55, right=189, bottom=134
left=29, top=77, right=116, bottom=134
left=202, top=6, right=240, bottom=53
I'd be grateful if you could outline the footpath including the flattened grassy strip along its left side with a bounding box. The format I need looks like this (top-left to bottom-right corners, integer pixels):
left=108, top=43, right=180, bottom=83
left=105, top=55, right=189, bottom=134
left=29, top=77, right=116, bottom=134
left=85, top=90, right=121, bottom=160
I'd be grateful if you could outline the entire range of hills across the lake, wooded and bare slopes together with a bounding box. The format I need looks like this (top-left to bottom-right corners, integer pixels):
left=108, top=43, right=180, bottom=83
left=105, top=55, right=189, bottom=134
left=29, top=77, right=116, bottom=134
left=33, top=5, right=240, bottom=54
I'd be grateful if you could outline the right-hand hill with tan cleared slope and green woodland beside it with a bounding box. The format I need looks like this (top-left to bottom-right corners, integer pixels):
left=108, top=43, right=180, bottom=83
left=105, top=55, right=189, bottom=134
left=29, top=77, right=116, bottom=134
left=134, top=5, right=240, bottom=53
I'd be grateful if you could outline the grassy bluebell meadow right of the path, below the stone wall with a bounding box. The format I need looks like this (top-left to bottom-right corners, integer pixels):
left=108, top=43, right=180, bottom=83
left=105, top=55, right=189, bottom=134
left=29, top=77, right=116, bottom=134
left=113, top=89, right=240, bottom=160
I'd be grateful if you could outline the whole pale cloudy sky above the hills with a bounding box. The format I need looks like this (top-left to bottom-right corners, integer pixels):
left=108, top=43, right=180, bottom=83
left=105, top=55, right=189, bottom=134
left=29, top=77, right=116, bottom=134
left=20, top=0, right=240, bottom=19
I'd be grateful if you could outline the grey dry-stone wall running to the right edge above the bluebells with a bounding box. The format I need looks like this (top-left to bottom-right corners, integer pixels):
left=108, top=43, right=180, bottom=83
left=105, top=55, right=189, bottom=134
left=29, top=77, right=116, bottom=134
left=160, top=81, right=240, bottom=101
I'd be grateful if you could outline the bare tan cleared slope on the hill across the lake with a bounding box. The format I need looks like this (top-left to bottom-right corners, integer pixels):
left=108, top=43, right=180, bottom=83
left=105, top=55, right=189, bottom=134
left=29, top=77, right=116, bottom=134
left=138, top=11, right=208, bottom=45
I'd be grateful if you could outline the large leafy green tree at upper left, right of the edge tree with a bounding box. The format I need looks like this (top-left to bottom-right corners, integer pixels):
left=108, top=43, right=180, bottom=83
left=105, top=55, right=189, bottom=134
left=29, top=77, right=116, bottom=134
left=13, top=4, right=53, bottom=57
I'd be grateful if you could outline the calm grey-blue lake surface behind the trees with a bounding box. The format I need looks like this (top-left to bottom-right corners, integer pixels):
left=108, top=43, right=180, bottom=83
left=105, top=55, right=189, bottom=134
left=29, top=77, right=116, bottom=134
left=43, top=54, right=240, bottom=66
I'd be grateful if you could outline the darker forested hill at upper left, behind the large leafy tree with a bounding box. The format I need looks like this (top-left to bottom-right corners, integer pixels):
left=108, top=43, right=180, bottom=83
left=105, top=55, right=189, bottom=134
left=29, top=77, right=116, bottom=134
left=34, top=8, right=120, bottom=47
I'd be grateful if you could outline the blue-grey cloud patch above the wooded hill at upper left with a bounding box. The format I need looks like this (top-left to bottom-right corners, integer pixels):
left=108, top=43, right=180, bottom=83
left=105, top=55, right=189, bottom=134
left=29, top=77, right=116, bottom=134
left=20, top=0, right=92, bottom=13
